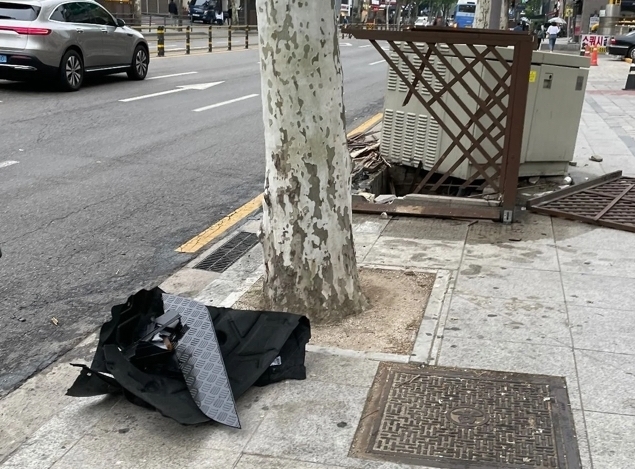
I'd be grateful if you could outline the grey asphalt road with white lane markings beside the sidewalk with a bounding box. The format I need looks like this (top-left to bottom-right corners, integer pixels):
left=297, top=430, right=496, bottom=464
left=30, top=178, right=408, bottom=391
left=0, top=40, right=386, bottom=395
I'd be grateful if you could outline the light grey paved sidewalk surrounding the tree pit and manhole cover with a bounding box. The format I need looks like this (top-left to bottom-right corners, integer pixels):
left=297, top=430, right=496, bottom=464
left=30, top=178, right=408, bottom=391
left=0, top=54, right=635, bottom=469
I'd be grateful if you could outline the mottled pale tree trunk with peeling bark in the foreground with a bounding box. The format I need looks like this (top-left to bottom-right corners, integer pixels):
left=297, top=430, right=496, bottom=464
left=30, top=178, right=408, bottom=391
left=256, top=0, right=363, bottom=323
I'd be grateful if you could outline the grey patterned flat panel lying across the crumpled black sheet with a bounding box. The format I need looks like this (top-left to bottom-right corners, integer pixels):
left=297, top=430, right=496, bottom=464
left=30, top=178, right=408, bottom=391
left=163, top=294, right=240, bottom=428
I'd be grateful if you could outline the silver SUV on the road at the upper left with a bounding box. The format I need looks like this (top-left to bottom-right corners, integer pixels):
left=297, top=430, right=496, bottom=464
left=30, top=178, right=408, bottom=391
left=0, top=0, right=150, bottom=91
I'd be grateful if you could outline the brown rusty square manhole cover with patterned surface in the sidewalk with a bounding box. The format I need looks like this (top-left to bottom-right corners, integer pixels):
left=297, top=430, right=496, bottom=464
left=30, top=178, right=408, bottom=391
left=351, top=363, right=581, bottom=469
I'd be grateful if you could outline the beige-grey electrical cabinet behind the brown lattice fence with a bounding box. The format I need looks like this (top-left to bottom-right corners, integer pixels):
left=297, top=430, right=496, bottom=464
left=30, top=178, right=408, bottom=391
left=380, top=45, right=589, bottom=179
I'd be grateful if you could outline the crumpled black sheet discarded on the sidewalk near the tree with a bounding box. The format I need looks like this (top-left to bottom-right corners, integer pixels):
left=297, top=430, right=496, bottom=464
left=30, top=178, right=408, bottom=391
left=67, top=288, right=311, bottom=425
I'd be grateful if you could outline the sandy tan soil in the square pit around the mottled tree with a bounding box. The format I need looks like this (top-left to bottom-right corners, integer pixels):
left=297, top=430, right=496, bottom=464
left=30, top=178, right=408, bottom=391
left=233, top=268, right=435, bottom=355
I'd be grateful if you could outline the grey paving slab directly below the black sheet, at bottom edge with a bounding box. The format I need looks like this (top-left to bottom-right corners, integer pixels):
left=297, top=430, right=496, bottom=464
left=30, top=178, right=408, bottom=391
left=44, top=385, right=278, bottom=469
